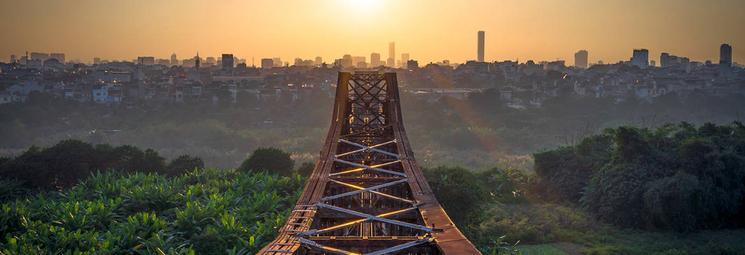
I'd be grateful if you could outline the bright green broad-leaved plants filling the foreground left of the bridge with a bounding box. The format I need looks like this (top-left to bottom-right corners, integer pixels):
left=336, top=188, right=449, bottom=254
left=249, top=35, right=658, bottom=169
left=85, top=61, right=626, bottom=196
left=0, top=169, right=304, bottom=254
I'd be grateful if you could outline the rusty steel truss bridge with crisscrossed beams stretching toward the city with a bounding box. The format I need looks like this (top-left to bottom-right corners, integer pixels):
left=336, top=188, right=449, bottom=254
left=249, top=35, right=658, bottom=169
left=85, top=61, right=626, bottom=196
left=259, top=71, right=481, bottom=255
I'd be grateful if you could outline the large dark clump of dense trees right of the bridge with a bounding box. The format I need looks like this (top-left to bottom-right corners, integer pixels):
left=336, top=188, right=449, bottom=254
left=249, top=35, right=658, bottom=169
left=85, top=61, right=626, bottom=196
left=535, top=123, right=745, bottom=231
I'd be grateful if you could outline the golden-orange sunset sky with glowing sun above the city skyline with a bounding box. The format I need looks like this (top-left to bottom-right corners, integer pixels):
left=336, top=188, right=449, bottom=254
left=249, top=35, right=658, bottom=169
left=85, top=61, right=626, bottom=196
left=0, top=0, right=745, bottom=65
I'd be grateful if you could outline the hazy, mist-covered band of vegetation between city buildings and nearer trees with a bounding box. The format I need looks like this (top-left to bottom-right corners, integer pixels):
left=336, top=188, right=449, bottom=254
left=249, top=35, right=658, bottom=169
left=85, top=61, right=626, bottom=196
left=0, top=88, right=745, bottom=170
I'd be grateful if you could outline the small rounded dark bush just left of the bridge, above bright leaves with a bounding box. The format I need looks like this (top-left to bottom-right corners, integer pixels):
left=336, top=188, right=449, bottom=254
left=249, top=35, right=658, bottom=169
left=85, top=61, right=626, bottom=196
left=238, top=148, right=295, bottom=176
